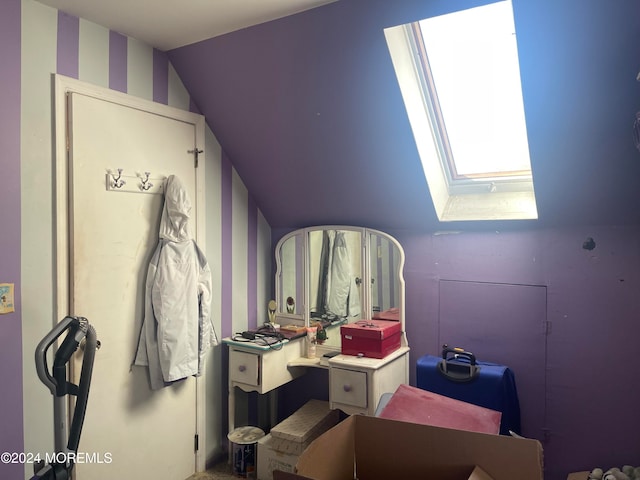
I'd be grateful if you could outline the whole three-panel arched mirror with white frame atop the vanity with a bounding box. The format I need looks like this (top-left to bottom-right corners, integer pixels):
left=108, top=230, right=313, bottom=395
left=275, top=225, right=404, bottom=349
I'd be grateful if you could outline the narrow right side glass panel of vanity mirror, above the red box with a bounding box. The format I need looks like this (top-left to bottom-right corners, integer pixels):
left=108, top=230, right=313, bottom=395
left=369, top=233, right=402, bottom=320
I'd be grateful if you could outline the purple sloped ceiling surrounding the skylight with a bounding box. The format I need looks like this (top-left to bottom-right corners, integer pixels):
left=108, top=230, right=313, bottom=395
left=44, top=0, right=640, bottom=231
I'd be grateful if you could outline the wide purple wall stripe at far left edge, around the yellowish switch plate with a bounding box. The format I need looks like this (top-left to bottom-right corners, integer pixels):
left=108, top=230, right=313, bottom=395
left=0, top=0, right=24, bottom=478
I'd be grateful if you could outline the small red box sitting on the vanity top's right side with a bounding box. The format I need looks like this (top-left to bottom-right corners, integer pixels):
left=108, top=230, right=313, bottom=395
left=340, top=320, right=402, bottom=358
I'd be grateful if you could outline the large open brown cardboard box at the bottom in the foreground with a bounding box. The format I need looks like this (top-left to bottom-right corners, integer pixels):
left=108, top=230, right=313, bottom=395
left=288, top=415, right=543, bottom=480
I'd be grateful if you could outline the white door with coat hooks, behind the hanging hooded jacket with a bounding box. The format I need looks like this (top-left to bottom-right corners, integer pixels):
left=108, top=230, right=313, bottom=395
left=68, top=93, right=202, bottom=480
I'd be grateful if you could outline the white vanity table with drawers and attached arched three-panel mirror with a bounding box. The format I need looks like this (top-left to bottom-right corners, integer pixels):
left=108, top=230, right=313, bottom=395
left=223, top=226, right=409, bottom=431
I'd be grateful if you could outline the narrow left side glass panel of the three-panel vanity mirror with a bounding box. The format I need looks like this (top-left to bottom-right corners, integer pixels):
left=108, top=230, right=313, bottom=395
left=277, top=234, right=304, bottom=315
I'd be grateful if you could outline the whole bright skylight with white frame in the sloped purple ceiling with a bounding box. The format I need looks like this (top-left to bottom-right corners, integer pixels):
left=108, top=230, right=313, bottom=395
left=385, top=0, right=537, bottom=221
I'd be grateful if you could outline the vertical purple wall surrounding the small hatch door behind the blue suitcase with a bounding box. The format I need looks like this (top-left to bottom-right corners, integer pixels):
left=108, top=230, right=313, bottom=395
left=389, top=227, right=640, bottom=480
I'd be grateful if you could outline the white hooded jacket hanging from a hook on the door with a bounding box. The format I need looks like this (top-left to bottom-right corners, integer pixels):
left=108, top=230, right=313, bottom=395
left=134, top=175, right=218, bottom=390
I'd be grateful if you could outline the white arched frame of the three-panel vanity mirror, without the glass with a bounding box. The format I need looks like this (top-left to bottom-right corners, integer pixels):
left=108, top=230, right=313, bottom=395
left=274, top=225, right=407, bottom=348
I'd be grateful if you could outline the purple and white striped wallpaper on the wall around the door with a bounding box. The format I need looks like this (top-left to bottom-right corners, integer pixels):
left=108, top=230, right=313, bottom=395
left=7, top=0, right=272, bottom=478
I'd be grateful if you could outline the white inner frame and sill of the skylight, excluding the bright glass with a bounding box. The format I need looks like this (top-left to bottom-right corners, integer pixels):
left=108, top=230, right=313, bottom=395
left=385, top=0, right=537, bottom=221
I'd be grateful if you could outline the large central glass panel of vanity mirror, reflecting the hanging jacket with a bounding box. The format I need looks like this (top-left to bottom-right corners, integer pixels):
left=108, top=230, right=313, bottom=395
left=308, top=229, right=362, bottom=323
